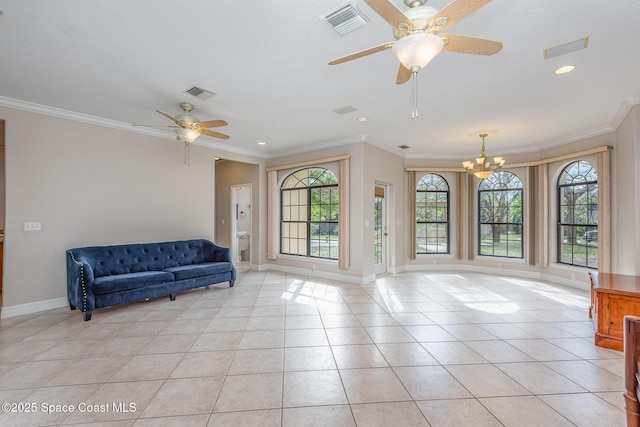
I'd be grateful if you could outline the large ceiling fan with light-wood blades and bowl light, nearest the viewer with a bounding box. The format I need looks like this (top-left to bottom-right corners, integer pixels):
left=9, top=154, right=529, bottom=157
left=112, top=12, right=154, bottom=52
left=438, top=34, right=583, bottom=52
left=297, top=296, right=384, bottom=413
left=329, top=0, right=502, bottom=118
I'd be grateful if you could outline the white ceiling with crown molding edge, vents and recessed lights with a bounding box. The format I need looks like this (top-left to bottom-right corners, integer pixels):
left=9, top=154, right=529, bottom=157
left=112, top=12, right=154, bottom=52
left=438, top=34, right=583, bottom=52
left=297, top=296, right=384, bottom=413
left=0, top=0, right=640, bottom=159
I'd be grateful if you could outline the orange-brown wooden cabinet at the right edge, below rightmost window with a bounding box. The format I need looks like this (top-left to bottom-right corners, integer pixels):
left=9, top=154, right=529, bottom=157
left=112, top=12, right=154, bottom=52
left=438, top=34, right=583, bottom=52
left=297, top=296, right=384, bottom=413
left=589, top=272, right=640, bottom=351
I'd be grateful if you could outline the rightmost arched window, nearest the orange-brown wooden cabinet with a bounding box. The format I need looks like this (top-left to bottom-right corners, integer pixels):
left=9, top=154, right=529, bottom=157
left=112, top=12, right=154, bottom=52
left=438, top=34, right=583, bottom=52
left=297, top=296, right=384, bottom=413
left=558, top=160, right=598, bottom=268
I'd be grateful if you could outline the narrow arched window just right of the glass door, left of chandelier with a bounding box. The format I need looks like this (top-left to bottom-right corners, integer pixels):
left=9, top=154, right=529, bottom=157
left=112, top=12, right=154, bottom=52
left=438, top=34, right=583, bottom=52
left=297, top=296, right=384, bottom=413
left=416, top=173, right=450, bottom=254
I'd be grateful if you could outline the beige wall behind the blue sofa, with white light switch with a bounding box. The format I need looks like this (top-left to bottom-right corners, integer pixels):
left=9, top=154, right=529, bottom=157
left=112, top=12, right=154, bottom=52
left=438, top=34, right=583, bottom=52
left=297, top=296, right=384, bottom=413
left=0, top=108, right=219, bottom=307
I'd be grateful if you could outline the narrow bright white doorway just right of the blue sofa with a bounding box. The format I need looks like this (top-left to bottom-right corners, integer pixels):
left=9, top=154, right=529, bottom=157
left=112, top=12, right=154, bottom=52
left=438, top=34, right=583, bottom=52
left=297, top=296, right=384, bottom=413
left=230, top=183, right=251, bottom=267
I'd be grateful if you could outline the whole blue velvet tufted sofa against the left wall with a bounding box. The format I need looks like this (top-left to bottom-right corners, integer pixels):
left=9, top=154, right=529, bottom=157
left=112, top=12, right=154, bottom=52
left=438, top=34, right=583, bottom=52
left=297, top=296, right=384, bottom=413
left=67, top=239, right=236, bottom=320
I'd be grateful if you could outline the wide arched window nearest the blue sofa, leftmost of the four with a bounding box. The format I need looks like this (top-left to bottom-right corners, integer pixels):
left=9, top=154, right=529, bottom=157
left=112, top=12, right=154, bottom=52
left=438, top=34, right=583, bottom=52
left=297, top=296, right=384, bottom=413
left=280, top=167, right=338, bottom=259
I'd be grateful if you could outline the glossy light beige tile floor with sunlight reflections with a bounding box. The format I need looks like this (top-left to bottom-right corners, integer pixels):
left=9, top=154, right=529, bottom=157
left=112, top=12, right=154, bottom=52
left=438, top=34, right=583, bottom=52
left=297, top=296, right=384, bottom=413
left=0, top=270, right=625, bottom=427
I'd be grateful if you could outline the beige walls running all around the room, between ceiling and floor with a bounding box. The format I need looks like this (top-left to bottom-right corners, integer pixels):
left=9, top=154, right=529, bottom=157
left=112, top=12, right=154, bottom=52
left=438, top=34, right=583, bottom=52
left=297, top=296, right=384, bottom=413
left=0, top=106, right=640, bottom=316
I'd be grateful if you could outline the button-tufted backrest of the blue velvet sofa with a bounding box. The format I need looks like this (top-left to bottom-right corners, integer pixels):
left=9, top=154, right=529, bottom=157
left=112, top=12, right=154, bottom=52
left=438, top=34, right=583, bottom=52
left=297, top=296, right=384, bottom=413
left=69, top=239, right=221, bottom=277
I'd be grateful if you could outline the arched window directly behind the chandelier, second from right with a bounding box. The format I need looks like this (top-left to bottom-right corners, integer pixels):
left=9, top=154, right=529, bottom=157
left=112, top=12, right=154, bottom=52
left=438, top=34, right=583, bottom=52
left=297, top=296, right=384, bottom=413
left=478, top=171, right=523, bottom=258
